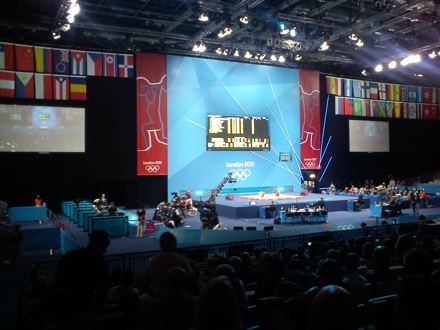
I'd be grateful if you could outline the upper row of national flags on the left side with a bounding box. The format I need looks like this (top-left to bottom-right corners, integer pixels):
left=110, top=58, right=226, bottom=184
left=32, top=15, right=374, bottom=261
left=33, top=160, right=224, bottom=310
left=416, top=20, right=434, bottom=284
left=0, top=42, right=134, bottom=78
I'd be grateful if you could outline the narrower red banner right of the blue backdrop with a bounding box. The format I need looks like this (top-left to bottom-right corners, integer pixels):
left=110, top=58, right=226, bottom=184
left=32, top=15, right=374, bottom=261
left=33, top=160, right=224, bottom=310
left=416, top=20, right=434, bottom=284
left=299, top=69, right=321, bottom=170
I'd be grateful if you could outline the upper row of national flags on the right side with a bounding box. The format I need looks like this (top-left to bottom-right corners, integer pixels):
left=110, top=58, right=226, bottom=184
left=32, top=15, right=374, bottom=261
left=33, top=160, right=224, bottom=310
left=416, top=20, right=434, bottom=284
left=326, top=76, right=440, bottom=104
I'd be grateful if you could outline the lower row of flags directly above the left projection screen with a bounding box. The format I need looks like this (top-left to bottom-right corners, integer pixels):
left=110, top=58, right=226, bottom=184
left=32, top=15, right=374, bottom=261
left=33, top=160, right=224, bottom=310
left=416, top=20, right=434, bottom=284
left=0, top=70, right=87, bottom=100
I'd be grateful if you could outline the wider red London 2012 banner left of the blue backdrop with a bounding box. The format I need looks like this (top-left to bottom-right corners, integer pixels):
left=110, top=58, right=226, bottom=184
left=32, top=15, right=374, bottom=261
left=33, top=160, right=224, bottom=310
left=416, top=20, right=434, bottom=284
left=136, top=53, right=168, bottom=175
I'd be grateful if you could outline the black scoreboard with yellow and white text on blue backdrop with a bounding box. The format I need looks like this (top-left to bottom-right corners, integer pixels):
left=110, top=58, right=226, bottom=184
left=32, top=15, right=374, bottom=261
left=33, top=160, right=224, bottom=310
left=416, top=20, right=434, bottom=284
left=206, top=115, right=270, bottom=151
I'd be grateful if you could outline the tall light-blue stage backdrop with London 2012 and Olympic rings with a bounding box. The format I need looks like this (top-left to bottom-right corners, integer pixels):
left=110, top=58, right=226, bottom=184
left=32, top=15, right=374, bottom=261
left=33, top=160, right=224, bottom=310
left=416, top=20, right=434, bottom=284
left=167, top=55, right=301, bottom=196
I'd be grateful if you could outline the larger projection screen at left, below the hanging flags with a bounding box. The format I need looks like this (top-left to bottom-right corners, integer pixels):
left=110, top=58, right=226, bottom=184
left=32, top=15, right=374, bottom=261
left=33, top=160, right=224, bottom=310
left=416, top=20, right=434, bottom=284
left=0, top=104, right=85, bottom=153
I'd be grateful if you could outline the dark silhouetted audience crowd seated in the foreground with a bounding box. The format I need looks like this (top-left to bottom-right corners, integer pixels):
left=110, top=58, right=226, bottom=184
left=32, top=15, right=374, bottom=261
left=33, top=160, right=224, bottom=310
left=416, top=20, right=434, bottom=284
left=14, top=215, right=440, bottom=330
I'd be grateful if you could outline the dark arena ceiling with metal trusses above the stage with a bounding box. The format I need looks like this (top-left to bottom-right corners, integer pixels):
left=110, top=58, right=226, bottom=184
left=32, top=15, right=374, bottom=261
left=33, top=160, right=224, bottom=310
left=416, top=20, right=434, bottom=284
left=0, top=0, right=440, bottom=81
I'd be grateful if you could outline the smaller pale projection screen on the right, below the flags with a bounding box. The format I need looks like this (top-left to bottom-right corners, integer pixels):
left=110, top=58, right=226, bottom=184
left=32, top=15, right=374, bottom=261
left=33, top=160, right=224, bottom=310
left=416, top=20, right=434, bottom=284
left=348, top=120, right=390, bottom=152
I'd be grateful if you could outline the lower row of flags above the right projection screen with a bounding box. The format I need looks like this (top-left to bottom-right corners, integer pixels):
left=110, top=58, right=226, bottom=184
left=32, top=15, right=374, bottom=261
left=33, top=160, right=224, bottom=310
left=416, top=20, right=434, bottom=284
left=335, top=96, right=440, bottom=120
